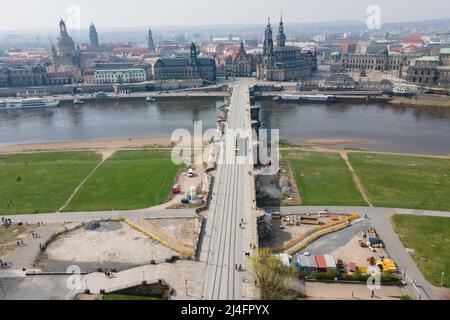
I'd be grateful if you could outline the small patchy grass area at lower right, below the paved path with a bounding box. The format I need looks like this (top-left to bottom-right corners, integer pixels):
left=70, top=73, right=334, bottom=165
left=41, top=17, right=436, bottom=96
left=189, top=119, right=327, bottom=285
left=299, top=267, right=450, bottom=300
left=392, top=215, right=450, bottom=288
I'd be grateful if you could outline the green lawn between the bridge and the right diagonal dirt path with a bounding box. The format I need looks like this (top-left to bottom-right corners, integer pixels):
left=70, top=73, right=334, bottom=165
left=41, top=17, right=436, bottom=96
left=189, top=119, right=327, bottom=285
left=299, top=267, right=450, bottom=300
left=282, top=151, right=367, bottom=206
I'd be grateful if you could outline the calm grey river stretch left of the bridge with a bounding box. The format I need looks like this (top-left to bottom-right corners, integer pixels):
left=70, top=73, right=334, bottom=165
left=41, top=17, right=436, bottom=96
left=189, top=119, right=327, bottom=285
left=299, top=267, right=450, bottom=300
left=0, top=99, right=221, bottom=145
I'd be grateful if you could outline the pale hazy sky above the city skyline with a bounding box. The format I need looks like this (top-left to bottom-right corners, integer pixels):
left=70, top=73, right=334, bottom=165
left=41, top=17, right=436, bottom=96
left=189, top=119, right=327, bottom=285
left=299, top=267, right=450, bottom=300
left=0, top=0, right=450, bottom=30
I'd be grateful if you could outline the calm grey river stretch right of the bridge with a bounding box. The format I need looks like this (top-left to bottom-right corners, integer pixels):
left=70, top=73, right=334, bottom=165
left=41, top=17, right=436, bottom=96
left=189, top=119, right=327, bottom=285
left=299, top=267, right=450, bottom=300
left=260, top=101, right=450, bottom=155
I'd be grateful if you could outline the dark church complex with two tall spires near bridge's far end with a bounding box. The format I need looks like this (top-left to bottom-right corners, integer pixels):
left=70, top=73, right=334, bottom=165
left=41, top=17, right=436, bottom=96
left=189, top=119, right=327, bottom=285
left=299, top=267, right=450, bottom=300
left=257, top=19, right=317, bottom=81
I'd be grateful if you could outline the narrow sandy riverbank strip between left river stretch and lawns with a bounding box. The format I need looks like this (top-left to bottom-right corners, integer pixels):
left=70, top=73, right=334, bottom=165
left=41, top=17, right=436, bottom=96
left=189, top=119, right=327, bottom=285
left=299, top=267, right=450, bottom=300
left=0, top=136, right=172, bottom=154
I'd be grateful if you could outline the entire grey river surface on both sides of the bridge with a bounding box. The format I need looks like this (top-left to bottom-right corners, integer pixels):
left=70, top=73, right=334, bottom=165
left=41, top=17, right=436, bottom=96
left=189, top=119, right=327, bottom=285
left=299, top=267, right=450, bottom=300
left=0, top=99, right=450, bottom=155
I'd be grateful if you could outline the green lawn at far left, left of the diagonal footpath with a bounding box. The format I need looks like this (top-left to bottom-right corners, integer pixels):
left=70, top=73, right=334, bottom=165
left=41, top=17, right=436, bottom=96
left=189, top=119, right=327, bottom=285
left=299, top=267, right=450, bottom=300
left=0, top=152, right=101, bottom=215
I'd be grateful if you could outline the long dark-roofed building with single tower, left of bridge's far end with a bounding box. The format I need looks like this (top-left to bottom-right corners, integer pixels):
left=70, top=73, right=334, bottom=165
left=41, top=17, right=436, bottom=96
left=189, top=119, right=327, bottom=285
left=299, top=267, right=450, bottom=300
left=153, top=43, right=217, bottom=82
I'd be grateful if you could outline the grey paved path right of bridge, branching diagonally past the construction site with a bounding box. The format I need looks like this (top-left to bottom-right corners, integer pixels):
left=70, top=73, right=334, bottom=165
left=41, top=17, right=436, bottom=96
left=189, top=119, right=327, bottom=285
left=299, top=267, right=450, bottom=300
left=266, top=206, right=450, bottom=300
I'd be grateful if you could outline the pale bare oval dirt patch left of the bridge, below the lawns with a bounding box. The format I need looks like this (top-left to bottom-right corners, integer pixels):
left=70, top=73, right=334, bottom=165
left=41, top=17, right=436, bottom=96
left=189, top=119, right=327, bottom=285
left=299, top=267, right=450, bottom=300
left=39, top=222, right=174, bottom=271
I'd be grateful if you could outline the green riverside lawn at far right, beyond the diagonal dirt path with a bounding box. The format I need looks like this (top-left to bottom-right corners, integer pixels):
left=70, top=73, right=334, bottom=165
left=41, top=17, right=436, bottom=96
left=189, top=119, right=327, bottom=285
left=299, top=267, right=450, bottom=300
left=349, top=153, right=450, bottom=211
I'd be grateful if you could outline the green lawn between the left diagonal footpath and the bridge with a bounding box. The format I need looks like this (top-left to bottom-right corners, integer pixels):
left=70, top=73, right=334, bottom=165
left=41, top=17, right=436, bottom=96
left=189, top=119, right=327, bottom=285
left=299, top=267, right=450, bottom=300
left=66, top=150, right=180, bottom=211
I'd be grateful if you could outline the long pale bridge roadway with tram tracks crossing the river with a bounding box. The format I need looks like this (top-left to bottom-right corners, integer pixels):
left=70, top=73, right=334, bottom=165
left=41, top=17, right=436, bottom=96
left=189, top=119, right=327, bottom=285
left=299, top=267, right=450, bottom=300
left=203, top=81, right=254, bottom=300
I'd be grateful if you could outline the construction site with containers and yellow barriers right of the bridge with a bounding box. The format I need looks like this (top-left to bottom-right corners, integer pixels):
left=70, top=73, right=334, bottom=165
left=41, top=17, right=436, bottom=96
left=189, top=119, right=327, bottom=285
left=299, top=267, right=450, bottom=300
left=258, top=210, right=402, bottom=298
